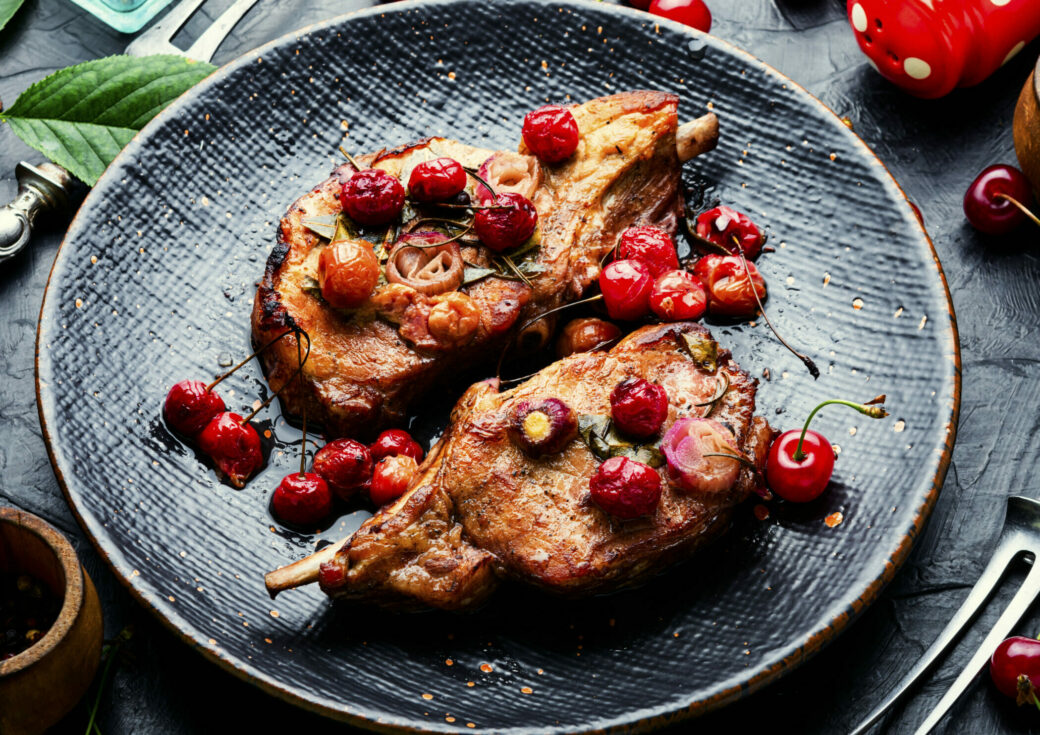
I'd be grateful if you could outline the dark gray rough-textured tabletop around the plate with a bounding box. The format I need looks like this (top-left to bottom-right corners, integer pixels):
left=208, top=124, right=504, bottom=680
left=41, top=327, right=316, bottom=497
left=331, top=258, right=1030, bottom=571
left=0, top=0, right=1040, bottom=735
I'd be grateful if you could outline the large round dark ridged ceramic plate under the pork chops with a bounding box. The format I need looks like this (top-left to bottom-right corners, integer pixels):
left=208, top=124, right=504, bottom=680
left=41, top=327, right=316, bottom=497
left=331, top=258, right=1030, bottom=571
left=38, top=2, right=959, bottom=732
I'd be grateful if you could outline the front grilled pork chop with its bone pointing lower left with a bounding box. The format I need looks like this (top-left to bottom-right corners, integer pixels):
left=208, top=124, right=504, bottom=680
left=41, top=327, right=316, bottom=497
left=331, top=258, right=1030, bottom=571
left=266, top=322, right=772, bottom=610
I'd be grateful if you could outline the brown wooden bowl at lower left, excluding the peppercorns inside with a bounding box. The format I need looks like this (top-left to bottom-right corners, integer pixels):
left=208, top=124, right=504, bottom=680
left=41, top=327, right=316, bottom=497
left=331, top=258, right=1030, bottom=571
left=0, top=507, right=103, bottom=735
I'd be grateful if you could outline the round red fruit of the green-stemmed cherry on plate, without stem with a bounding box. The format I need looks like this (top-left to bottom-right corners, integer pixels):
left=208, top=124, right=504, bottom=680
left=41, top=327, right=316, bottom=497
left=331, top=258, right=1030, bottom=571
left=765, top=428, right=834, bottom=503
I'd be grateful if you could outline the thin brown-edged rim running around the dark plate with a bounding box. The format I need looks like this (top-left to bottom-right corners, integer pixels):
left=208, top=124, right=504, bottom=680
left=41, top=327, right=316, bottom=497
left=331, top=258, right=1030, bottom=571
left=34, top=0, right=961, bottom=733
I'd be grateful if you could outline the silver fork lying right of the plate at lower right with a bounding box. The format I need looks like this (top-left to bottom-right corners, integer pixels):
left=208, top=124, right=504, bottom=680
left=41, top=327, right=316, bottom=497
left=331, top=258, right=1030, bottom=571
left=850, top=496, right=1040, bottom=735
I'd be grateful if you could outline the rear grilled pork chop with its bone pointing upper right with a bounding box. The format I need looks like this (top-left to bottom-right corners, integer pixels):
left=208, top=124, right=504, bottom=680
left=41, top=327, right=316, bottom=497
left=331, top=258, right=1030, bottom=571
left=253, top=91, right=718, bottom=438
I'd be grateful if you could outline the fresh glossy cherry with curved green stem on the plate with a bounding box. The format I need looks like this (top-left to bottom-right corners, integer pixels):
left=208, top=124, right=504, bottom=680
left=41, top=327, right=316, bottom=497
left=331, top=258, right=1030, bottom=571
left=765, top=395, right=888, bottom=503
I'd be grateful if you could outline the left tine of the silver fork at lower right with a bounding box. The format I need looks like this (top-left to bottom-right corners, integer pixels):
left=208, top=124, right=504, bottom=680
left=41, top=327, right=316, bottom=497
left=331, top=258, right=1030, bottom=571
left=849, top=536, right=1022, bottom=735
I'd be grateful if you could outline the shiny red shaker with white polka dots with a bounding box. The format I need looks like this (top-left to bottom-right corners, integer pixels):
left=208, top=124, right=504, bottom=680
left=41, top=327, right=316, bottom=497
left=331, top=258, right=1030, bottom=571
left=848, top=0, right=1040, bottom=99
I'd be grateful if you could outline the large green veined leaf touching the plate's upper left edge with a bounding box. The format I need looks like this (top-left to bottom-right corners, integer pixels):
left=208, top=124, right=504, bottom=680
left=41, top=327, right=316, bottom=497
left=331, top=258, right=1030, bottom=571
left=0, top=55, right=216, bottom=186
